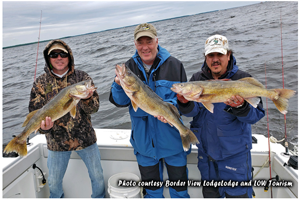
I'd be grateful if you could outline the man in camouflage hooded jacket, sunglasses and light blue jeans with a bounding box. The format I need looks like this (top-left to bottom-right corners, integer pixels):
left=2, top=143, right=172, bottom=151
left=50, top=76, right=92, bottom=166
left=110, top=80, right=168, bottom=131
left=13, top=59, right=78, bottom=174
left=29, top=40, right=105, bottom=197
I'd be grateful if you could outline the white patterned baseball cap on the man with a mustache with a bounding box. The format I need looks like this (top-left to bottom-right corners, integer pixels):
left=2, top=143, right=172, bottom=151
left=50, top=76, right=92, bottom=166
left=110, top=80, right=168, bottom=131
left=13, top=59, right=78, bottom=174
left=205, top=35, right=229, bottom=56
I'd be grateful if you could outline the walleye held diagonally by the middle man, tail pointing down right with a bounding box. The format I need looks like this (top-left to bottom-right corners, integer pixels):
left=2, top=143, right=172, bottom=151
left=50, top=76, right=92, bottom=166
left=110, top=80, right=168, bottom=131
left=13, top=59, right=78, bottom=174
left=115, top=64, right=199, bottom=151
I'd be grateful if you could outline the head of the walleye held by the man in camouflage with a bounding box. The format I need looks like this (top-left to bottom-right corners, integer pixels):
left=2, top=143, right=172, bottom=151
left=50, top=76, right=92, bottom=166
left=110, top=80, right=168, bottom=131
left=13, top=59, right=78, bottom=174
left=70, top=80, right=97, bottom=98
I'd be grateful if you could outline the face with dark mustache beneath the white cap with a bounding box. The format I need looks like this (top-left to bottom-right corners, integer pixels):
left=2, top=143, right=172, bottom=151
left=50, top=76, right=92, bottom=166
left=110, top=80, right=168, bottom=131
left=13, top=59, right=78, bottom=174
left=205, top=52, right=230, bottom=78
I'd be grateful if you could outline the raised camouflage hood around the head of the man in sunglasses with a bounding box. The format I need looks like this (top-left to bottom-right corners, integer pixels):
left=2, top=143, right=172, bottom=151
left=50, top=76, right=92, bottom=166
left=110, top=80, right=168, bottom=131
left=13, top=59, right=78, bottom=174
left=43, top=39, right=75, bottom=77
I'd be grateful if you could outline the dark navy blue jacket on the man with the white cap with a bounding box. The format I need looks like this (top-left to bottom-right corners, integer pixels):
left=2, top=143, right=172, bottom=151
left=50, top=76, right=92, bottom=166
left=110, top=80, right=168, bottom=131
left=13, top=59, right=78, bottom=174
left=178, top=55, right=265, bottom=160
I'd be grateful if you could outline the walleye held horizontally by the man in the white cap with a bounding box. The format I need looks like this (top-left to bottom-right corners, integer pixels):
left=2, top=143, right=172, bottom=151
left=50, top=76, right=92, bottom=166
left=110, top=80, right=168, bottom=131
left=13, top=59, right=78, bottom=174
left=171, top=77, right=295, bottom=114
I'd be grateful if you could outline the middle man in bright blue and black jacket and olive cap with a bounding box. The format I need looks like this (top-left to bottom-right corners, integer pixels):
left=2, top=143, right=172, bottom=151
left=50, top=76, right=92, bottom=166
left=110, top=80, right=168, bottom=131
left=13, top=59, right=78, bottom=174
left=109, top=23, right=190, bottom=198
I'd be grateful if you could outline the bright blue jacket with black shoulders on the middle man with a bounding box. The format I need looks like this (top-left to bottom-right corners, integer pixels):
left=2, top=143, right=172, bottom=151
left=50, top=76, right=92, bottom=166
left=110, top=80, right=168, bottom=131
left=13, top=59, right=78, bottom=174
left=109, top=46, right=187, bottom=159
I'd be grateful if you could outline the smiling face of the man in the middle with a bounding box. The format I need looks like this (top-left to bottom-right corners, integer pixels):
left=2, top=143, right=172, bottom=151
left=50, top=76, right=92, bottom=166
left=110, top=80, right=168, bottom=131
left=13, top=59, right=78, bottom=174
left=135, top=36, right=158, bottom=65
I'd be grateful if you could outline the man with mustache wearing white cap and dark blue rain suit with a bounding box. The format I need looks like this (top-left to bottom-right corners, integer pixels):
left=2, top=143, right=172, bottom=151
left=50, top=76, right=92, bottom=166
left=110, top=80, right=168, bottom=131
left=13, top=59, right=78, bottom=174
left=177, top=35, right=265, bottom=198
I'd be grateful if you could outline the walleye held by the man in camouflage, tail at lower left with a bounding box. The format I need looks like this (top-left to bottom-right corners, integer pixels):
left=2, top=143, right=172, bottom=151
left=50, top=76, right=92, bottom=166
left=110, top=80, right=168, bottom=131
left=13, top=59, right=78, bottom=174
left=4, top=80, right=97, bottom=156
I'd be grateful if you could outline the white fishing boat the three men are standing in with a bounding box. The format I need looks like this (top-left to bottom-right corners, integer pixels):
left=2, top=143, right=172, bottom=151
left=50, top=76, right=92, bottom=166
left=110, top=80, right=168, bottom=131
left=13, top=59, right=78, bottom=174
left=1, top=129, right=298, bottom=198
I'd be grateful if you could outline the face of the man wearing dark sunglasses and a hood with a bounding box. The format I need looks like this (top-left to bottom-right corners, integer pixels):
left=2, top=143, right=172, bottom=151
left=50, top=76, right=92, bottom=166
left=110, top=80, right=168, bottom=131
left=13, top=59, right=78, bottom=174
left=50, top=50, right=69, bottom=75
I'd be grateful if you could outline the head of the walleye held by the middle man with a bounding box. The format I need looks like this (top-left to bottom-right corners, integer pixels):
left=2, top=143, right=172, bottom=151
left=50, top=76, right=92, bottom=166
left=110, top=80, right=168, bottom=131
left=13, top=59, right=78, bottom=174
left=115, top=64, right=137, bottom=90
